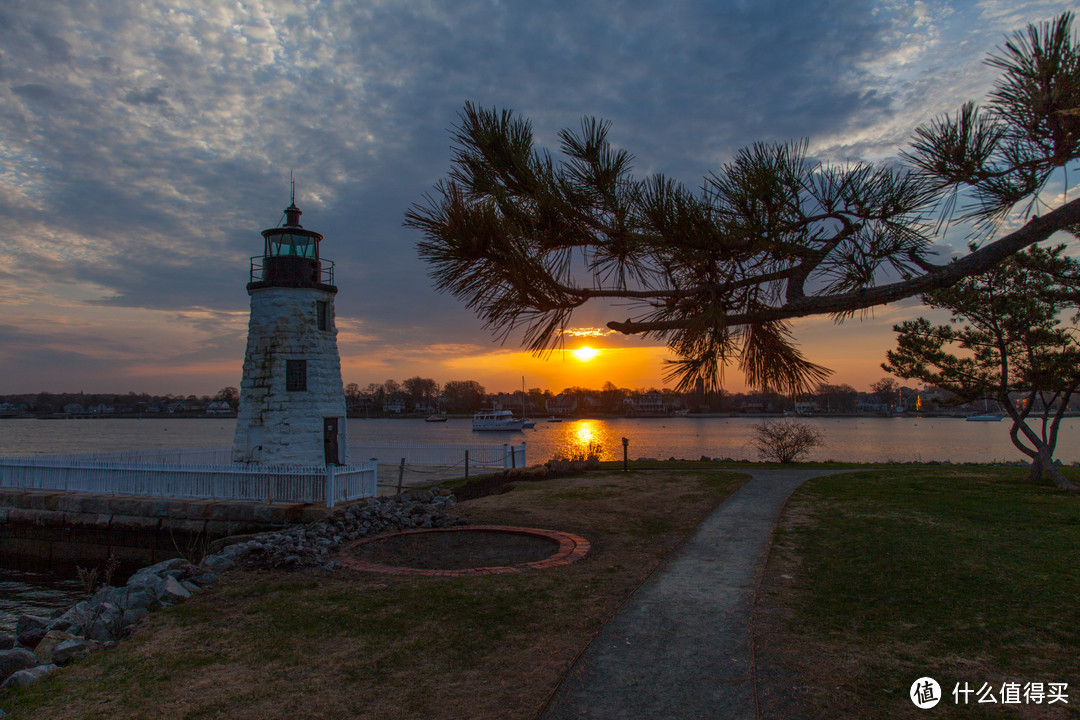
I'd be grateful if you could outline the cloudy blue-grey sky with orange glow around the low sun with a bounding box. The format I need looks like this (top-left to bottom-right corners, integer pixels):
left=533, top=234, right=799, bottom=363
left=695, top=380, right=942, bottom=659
left=0, top=0, right=1068, bottom=394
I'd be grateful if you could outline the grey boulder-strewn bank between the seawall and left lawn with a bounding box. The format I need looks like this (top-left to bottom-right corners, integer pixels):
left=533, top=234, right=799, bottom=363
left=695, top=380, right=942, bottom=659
left=0, top=490, right=464, bottom=699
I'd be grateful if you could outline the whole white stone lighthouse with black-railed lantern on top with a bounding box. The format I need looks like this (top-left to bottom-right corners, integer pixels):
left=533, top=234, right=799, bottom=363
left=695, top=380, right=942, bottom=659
left=232, top=191, right=349, bottom=465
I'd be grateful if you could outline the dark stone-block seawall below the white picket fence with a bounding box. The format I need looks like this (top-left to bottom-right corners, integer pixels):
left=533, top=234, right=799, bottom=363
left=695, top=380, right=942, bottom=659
left=0, top=489, right=330, bottom=569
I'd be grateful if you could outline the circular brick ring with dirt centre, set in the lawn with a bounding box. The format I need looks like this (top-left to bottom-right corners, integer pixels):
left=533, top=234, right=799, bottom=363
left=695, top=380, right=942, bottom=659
left=337, top=525, right=590, bottom=578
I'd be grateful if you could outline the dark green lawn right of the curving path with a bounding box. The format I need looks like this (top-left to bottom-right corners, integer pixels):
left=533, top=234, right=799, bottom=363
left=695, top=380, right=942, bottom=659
left=755, top=466, right=1080, bottom=719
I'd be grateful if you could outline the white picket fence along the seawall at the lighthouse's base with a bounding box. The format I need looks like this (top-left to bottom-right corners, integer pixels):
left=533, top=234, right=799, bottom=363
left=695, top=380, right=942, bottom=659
left=0, top=453, right=378, bottom=507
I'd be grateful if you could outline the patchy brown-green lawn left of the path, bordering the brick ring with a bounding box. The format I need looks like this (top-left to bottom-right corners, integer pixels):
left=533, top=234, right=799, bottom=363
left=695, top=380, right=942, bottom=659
left=0, top=470, right=745, bottom=720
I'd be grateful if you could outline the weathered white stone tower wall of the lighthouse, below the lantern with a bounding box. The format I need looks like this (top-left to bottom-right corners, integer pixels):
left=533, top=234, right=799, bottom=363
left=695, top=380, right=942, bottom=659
left=232, top=287, right=349, bottom=465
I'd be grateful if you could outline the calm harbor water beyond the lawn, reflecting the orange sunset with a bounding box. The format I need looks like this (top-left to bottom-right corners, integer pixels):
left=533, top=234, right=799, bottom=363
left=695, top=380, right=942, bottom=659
left=0, top=417, right=1080, bottom=463
